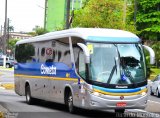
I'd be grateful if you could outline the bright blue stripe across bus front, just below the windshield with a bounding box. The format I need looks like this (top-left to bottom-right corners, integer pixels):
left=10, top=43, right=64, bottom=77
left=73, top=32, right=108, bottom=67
left=93, top=85, right=146, bottom=93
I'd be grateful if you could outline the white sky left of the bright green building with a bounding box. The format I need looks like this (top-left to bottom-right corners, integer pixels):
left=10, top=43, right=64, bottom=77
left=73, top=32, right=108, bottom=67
left=0, top=0, right=45, bottom=32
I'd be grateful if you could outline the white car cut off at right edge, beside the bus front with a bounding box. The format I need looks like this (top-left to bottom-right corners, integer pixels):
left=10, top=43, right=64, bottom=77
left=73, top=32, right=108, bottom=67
left=150, top=74, right=160, bottom=97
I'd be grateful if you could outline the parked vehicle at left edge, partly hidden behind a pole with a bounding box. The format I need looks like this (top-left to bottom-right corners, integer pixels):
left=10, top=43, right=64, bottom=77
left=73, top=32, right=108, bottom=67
left=0, top=57, right=14, bottom=68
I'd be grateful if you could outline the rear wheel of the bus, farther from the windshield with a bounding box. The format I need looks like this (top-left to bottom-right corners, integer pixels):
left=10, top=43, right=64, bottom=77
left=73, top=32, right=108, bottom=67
left=25, top=85, right=34, bottom=105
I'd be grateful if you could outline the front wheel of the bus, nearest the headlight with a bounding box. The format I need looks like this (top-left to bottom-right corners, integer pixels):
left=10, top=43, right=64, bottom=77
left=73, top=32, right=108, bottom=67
left=64, top=87, right=76, bottom=113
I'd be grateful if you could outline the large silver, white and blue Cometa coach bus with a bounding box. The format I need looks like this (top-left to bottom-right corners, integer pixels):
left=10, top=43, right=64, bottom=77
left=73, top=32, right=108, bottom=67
left=14, top=28, right=155, bottom=113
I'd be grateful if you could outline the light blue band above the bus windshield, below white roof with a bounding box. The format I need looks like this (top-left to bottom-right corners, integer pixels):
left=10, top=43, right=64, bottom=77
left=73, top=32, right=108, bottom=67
left=87, top=34, right=141, bottom=43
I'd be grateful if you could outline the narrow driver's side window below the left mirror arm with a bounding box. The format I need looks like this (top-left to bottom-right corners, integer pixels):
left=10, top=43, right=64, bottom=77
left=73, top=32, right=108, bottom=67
left=78, top=51, right=86, bottom=79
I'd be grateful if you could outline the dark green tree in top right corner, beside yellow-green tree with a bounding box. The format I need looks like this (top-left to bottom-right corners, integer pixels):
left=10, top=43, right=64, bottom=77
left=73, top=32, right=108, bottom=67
left=136, top=0, right=160, bottom=40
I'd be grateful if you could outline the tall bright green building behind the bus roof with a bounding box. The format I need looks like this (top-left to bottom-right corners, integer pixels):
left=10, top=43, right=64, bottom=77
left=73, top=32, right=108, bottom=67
left=44, top=0, right=85, bottom=31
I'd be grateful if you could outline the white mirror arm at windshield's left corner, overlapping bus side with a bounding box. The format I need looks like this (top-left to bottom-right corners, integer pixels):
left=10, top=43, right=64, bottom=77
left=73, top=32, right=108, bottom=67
left=77, top=43, right=90, bottom=63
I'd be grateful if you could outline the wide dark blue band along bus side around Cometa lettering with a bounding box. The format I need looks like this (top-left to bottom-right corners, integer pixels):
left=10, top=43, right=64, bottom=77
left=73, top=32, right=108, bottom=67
left=14, top=62, right=78, bottom=78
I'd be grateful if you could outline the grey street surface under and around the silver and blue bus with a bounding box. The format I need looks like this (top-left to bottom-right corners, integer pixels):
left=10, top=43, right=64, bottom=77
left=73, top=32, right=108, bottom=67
left=0, top=69, right=160, bottom=118
